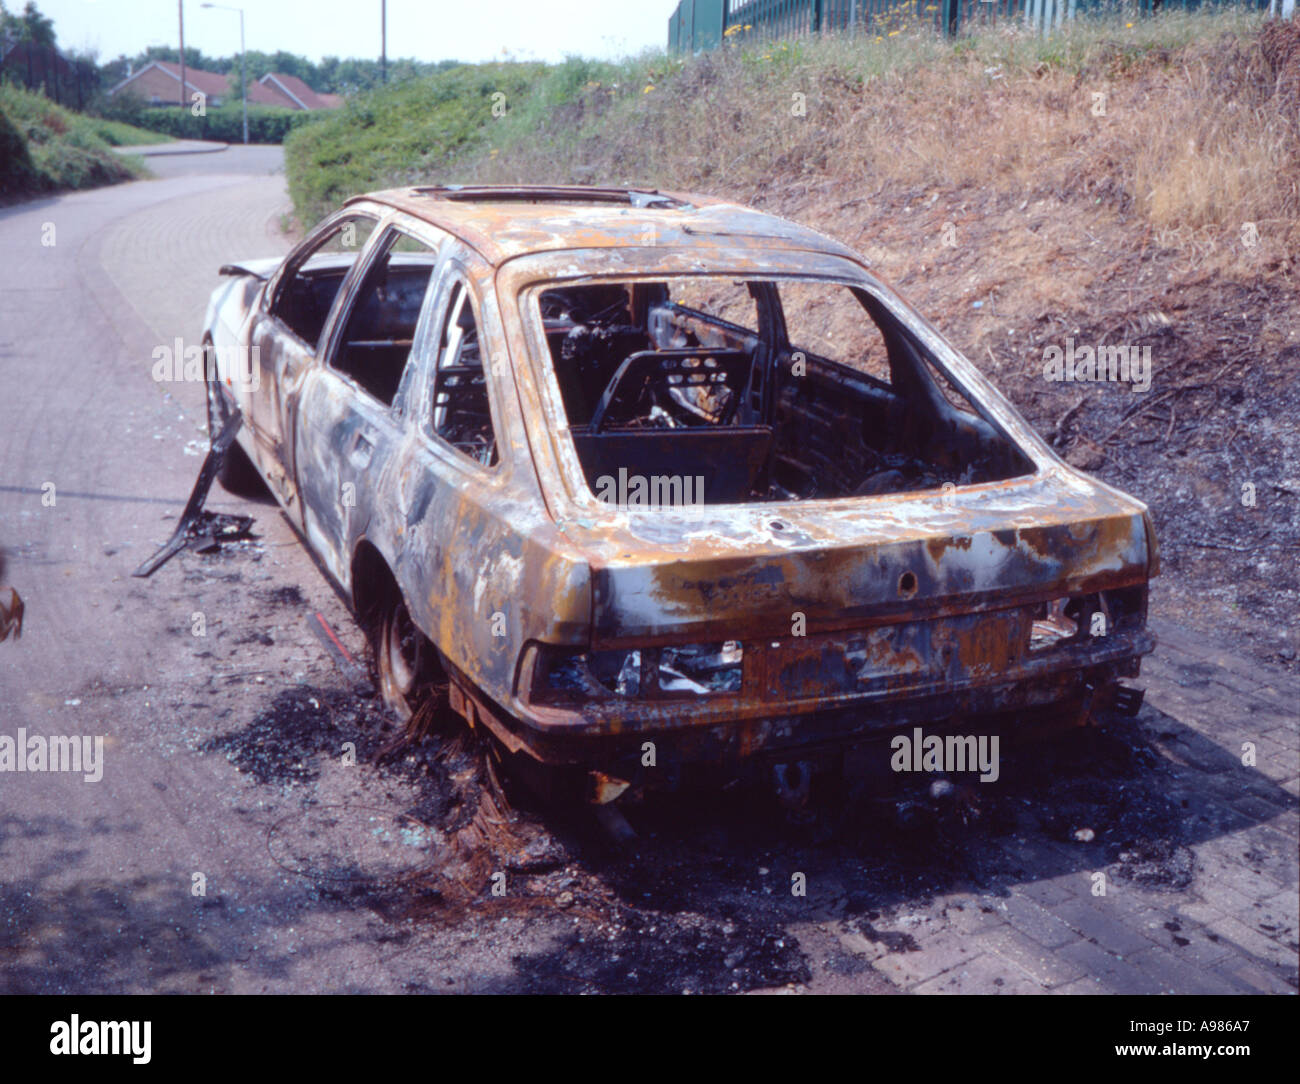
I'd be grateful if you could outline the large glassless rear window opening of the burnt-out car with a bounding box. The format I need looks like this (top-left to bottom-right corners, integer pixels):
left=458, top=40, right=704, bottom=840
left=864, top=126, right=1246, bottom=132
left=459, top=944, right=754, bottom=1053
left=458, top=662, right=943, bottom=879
left=540, top=276, right=1034, bottom=504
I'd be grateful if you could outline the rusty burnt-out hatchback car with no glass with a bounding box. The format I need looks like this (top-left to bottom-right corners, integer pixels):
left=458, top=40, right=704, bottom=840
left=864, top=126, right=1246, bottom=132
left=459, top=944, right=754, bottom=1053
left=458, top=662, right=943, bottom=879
left=205, top=187, right=1157, bottom=793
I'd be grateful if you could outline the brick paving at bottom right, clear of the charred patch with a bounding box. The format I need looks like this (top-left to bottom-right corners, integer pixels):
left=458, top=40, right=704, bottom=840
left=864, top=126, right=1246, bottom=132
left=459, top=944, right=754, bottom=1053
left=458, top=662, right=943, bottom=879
left=795, top=624, right=1300, bottom=994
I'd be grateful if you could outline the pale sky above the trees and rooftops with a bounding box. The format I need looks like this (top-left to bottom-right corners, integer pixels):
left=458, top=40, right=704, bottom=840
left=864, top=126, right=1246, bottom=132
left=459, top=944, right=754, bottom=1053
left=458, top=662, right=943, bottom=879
left=22, top=0, right=677, bottom=62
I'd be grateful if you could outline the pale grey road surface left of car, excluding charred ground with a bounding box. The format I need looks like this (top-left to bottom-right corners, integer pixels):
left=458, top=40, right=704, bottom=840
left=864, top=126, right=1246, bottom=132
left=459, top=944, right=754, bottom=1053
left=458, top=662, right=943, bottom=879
left=0, top=148, right=538, bottom=992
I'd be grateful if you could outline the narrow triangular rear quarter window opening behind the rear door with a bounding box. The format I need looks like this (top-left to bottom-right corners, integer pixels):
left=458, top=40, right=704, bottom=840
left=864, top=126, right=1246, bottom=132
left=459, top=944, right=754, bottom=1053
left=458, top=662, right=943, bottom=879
left=433, top=282, right=497, bottom=467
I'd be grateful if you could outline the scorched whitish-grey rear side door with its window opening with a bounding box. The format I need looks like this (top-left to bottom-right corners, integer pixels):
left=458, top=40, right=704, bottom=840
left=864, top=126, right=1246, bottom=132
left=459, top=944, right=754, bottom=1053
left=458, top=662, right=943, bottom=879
left=294, top=225, right=438, bottom=585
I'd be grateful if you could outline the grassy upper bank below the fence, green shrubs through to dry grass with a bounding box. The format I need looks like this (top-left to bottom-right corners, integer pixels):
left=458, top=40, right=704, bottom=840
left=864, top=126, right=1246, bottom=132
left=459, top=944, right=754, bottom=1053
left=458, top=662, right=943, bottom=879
left=287, top=13, right=1300, bottom=263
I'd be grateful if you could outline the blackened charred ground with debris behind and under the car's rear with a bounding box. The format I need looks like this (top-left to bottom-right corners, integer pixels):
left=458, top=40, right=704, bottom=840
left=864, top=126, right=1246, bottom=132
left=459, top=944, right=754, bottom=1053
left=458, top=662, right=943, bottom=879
left=197, top=649, right=1296, bottom=993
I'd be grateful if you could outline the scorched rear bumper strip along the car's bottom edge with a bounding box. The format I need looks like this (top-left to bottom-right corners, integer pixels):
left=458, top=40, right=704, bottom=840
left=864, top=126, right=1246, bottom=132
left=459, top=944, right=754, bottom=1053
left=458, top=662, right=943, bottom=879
left=473, top=616, right=1156, bottom=779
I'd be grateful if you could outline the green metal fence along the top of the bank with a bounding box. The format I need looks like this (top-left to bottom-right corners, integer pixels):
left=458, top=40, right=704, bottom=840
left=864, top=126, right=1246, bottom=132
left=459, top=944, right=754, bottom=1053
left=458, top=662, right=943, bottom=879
left=668, top=0, right=1270, bottom=52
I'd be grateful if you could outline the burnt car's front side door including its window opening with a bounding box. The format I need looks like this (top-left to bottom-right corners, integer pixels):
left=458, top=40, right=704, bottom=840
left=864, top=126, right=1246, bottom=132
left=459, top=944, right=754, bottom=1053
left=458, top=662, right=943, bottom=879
left=246, top=212, right=378, bottom=514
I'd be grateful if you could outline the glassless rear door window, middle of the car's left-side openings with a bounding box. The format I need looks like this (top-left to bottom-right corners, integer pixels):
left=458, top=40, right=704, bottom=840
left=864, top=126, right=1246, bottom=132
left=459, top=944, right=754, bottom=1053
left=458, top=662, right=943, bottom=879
left=330, top=230, right=438, bottom=406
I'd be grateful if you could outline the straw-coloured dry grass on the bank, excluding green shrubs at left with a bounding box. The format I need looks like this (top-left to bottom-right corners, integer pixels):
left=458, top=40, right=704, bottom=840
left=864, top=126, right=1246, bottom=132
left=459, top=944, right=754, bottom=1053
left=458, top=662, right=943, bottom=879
left=456, top=14, right=1300, bottom=274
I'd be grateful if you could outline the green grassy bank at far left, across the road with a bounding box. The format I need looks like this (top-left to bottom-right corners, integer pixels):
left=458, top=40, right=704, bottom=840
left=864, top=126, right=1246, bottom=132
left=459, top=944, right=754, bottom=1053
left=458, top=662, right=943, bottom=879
left=0, top=86, right=150, bottom=200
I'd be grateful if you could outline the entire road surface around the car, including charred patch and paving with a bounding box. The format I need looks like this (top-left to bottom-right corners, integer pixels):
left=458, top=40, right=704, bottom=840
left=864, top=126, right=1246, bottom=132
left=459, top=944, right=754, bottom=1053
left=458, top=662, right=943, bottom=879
left=0, top=147, right=1300, bottom=993
